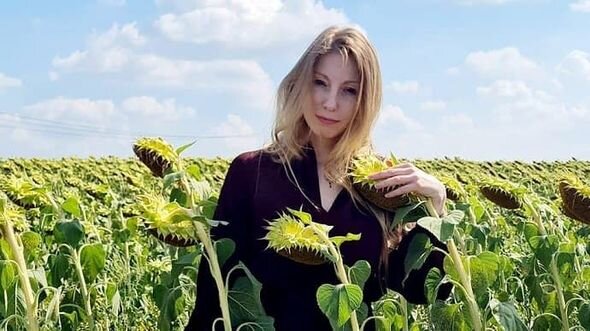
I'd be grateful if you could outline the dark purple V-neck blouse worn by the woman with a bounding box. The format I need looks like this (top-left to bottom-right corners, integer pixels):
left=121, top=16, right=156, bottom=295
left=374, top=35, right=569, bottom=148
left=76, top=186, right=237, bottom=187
left=186, top=148, right=450, bottom=331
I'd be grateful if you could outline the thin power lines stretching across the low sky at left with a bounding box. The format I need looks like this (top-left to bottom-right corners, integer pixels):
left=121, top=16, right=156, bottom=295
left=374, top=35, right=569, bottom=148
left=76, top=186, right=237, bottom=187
left=0, top=112, right=256, bottom=139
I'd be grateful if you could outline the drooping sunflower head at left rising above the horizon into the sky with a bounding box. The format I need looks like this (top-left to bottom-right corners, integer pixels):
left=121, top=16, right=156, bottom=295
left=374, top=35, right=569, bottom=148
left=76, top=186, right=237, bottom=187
left=133, top=138, right=180, bottom=177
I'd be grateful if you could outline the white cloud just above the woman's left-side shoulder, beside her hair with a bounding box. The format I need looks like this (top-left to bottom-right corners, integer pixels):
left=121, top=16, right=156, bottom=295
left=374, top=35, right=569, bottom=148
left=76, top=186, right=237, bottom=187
left=212, top=114, right=262, bottom=155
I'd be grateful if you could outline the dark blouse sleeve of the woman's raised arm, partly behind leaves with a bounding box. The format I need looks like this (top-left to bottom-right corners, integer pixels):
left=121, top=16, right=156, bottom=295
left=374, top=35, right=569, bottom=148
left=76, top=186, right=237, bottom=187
left=387, top=226, right=452, bottom=304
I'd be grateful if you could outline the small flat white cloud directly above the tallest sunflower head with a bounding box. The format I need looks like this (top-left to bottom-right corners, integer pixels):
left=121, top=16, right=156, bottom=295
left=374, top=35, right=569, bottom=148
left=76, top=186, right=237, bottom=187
left=121, top=96, right=196, bottom=121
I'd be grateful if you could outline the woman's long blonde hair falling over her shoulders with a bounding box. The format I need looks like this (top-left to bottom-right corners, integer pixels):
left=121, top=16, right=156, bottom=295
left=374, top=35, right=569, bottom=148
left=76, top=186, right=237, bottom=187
left=266, top=26, right=388, bottom=272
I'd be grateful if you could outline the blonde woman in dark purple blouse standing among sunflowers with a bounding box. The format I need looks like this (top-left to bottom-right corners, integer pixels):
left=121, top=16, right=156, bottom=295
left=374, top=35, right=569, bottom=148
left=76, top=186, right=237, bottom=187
left=187, top=27, right=449, bottom=331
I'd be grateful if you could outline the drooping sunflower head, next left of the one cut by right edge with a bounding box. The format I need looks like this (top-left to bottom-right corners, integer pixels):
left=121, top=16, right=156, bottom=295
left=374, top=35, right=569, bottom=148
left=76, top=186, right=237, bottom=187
left=479, top=178, right=526, bottom=209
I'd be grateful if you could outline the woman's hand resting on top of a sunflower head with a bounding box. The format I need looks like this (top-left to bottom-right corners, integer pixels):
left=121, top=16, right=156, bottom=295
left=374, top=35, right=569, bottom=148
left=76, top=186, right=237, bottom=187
left=369, top=163, right=447, bottom=215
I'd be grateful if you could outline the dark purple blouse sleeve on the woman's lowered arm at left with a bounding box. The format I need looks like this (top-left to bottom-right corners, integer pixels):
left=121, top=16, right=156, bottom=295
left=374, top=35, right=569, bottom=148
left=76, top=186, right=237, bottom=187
left=185, top=154, right=253, bottom=331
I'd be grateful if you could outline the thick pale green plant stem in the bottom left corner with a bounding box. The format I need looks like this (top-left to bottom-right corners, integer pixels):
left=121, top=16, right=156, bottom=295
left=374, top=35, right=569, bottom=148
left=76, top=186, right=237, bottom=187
left=2, top=222, right=39, bottom=331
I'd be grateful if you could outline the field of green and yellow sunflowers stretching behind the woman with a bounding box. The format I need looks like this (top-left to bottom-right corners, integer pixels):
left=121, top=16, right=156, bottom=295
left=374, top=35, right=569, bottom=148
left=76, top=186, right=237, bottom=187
left=0, top=138, right=590, bottom=331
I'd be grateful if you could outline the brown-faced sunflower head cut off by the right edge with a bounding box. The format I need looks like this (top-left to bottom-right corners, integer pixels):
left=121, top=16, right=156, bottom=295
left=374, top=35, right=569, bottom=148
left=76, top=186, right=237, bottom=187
left=559, top=174, right=590, bottom=224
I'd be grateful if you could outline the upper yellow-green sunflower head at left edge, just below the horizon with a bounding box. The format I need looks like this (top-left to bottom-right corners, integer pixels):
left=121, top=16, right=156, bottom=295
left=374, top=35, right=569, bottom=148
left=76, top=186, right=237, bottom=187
left=0, top=177, right=50, bottom=209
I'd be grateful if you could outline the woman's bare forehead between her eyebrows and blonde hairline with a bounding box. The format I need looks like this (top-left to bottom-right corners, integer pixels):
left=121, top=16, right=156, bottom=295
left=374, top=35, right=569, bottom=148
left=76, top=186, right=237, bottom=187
left=314, top=53, right=359, bottom=83
